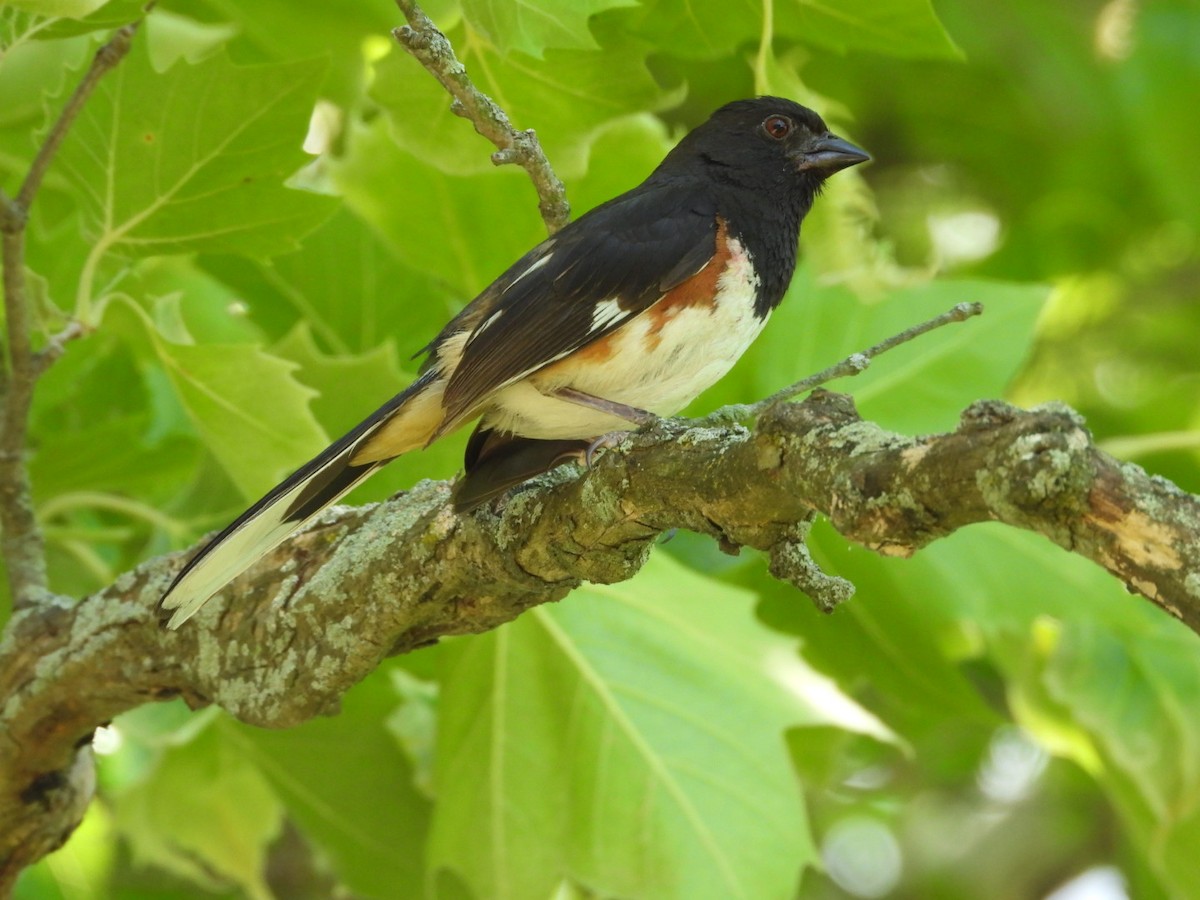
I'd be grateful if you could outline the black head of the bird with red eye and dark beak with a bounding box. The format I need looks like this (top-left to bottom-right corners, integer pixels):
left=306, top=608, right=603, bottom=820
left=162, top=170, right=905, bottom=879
left=659, top=97, right=871, bottom=192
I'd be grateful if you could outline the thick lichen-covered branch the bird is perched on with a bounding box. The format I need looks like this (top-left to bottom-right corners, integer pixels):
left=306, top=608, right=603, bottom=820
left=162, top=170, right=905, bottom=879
left=0, top=392, right=1200, bottom=872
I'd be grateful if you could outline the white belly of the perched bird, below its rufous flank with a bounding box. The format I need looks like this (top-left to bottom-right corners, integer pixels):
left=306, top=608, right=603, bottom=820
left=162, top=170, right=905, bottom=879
left=486, top=252, right=767, bottom=439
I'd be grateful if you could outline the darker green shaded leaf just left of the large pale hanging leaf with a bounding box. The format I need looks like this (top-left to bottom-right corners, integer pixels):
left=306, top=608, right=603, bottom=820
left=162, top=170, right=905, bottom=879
left=230, top=670, right=430, bottom=898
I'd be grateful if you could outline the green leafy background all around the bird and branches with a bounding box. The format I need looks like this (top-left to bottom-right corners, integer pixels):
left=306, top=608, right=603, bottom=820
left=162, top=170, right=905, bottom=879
left=0, top=0, right=1200, bottom=898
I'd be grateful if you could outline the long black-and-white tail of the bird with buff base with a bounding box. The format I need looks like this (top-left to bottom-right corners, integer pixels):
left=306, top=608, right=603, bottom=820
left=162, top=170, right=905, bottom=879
left=162, top=371, right=442, bottom=629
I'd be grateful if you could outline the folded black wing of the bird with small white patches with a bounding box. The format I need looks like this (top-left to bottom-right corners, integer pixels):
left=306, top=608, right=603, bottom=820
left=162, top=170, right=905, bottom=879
left=431, top=180, right=718, bottom=427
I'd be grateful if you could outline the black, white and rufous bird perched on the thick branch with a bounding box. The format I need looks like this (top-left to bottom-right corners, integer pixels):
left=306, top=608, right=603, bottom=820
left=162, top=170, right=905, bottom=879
left=161, top=96, right=870, bottom=629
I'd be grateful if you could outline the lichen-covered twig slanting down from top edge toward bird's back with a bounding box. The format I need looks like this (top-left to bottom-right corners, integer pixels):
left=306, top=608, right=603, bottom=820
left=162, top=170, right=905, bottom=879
left=391, top=0, right=571, bottom=234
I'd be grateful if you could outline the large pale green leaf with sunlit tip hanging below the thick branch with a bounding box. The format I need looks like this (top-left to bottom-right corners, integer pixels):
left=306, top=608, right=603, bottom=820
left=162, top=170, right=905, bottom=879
left=430, top=554, right=886, bottom=898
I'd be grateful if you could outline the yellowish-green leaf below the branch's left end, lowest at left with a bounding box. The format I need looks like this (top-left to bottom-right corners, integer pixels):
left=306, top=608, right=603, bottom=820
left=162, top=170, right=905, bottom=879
left=115, top=726, right=282, bottom=900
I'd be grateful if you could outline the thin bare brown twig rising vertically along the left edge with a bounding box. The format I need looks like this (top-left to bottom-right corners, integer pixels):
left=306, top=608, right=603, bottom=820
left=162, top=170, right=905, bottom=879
left=0, top=23, right=140, bottom=607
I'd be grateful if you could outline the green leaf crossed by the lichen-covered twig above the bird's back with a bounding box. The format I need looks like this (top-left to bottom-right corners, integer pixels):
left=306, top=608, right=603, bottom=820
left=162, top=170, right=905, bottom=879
left=371, top=34, right=683, bottom=178
